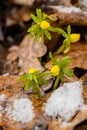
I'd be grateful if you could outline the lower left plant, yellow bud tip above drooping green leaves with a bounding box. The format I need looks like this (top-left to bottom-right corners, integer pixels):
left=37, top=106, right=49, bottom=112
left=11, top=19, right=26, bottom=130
left=19, top=68, right=50, bottom=97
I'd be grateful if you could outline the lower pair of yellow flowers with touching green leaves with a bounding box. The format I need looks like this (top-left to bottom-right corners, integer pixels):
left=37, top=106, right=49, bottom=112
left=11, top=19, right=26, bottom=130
left=19, top=53, right=74, bottom=97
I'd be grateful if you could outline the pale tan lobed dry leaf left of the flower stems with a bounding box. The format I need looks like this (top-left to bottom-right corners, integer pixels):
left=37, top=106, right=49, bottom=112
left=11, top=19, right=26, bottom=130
left=19, top=35, right=47, bottom=74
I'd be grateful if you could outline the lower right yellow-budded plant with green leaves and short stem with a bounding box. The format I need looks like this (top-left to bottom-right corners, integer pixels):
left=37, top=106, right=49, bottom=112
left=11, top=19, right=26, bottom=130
left=50, top=53, right=74, bottom=90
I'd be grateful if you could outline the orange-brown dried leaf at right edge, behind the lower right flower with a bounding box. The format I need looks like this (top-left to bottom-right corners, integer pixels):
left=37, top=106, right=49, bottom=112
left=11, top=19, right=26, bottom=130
left=45, top=42, right=87, bottom=70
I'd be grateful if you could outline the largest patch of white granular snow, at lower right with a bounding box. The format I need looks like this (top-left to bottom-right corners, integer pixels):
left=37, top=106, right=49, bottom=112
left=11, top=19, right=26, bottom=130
left=45, top=81, right=84, bottom=121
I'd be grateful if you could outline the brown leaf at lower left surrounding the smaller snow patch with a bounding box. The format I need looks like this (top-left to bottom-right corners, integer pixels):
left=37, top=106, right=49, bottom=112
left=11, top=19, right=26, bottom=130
left=0, top=76, right=48, bottom=130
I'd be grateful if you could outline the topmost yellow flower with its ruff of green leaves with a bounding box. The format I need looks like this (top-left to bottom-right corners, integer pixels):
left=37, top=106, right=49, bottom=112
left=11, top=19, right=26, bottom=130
left=28, top=9, right=57, bottom=43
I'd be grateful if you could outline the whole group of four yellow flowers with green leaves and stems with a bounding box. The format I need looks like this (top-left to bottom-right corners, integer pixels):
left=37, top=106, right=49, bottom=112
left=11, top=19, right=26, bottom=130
left=19, top=9, right=80, bottom=96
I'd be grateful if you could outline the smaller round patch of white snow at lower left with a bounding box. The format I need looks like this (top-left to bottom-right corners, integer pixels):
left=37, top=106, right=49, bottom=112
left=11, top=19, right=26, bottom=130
left=5, top=98, right=35, bottom=123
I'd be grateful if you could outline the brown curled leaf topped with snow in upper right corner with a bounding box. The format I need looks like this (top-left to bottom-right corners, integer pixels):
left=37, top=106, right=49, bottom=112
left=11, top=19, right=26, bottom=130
left=50, top=4, right=87, bottom=26
